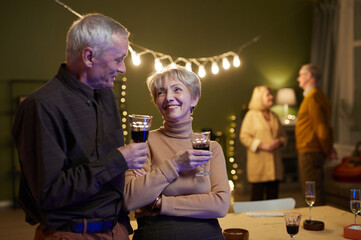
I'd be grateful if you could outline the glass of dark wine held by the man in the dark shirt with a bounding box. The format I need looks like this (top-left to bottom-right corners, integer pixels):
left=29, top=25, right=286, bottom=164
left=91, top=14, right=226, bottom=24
left=129, top=114, right=153, bottom=143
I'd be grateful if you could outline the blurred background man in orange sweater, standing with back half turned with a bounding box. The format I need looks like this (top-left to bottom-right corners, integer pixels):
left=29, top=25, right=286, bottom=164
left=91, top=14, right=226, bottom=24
left=296, top=64, right=336, bottom=205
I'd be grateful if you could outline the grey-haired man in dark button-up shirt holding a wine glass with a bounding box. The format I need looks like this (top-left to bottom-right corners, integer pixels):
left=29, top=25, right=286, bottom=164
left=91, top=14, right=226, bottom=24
left=13, top=14, right=148, bottom=239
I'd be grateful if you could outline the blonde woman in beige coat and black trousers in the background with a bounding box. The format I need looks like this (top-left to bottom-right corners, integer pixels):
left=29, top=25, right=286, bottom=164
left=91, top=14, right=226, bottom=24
left=240, top=86, right=287, bottom=201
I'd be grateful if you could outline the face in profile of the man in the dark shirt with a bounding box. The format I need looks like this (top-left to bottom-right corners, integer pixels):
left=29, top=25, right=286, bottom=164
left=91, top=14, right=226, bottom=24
left=86, top=35, right=129, bottom=89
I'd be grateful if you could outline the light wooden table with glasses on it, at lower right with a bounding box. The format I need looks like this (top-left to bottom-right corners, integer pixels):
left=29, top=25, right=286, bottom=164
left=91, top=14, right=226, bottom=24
left=219, top=206, right=352, bottom=240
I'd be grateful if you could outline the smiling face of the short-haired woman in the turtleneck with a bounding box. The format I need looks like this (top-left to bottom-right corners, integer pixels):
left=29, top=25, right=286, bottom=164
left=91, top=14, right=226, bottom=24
left=155, top=78, right=198, bottom=122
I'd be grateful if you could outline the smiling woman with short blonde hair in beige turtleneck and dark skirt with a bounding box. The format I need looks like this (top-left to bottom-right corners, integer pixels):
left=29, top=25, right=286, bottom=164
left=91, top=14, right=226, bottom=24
left=125, top=67, right=230, bottom=240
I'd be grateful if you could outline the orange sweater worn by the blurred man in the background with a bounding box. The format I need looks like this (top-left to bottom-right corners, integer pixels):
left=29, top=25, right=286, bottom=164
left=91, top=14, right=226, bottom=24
left=295, top=88, right=333, bottom=155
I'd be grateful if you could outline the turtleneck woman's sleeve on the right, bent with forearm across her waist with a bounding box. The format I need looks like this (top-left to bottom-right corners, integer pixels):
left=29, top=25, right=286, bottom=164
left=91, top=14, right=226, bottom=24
left=161, top=142, right=230, bottom=218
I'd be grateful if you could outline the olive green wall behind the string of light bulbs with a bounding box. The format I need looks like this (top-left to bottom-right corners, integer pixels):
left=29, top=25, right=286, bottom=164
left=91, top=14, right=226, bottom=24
left=0, top=0, right=314, bottom=201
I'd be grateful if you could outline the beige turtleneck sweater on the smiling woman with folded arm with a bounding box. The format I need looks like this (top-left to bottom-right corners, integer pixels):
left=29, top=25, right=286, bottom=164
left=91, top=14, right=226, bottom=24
left=124, top=118, right=230, bottom=218
